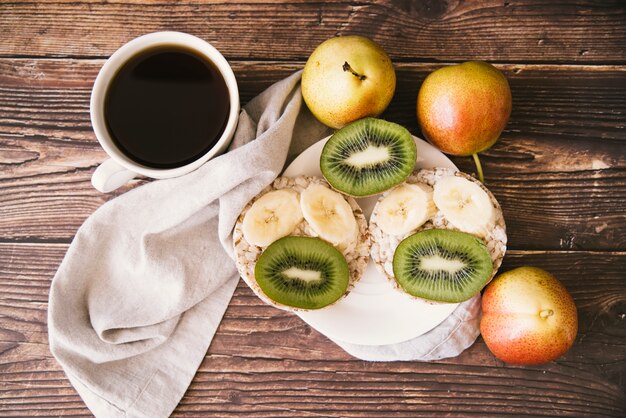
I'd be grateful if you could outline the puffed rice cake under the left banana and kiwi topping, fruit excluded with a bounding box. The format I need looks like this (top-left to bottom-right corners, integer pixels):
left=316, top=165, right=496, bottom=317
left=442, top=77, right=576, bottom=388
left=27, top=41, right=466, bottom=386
left=233, top=176, right=370, bottom=311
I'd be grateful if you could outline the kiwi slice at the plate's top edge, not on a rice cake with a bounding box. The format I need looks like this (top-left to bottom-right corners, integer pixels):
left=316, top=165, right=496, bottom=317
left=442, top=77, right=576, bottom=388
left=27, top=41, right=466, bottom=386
left=320, top=118, right=417, bottom=197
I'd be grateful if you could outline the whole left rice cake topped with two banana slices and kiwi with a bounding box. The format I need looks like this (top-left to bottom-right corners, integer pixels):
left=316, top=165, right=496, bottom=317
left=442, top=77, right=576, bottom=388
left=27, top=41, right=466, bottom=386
left=233, top=176, right=370, bottom=311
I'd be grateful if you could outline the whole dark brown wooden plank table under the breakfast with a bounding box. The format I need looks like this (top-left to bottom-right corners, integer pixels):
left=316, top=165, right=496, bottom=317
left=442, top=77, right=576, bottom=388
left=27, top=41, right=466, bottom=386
left=0, top=0, right=626, bottom=417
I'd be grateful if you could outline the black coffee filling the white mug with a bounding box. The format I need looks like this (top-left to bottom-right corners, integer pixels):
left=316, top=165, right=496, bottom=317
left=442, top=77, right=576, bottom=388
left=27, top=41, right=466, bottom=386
left=104, top=45, right=230, bottom=168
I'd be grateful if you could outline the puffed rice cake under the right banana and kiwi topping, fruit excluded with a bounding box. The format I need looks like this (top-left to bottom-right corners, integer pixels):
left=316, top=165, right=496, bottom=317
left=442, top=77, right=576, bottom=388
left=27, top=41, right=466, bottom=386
left=369, top=168, right=507, bottom=304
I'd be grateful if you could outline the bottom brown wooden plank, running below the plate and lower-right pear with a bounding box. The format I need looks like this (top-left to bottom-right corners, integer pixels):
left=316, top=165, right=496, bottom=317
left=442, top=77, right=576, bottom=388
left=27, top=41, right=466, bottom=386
left=0, top=244, right=626, bottom=417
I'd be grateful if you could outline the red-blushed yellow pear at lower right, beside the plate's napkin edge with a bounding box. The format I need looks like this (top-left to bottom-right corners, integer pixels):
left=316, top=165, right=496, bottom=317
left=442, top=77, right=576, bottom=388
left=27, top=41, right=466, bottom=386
left=480, top=267, right=578, bottom=365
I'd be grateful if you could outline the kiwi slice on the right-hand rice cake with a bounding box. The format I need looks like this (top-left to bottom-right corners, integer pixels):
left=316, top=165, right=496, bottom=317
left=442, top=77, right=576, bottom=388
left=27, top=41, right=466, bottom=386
left=393, top=229, right=493, bottom=303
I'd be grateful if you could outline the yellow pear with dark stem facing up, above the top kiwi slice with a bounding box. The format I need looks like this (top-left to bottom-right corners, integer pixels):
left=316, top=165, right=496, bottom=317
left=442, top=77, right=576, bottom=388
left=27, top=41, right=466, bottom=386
left=302, top=36, right=396, bottom=129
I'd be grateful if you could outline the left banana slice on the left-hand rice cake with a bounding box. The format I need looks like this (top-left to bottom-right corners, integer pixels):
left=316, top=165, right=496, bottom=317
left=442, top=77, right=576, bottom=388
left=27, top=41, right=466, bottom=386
left=241, top=189, right=303, bottom=247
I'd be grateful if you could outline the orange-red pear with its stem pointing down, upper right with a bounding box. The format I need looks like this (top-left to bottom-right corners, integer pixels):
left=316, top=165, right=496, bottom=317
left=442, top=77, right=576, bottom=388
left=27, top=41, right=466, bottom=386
left=417, top=61, right=512, bottom=182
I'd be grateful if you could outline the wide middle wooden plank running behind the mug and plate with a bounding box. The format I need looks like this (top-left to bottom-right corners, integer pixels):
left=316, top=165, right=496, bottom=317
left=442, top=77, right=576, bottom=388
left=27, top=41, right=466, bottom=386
left=0, top=59, right=626, bottom=250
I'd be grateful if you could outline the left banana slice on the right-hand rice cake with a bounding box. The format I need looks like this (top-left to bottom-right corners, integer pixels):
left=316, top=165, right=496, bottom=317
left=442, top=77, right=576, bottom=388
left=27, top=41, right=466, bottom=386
left=376, top=183, right=436, bottom=235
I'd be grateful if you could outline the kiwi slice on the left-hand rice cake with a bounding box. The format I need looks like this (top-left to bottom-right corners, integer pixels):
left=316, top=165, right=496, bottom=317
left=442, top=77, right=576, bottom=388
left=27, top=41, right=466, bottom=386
left=254, top=236, right=350, bottom=309
